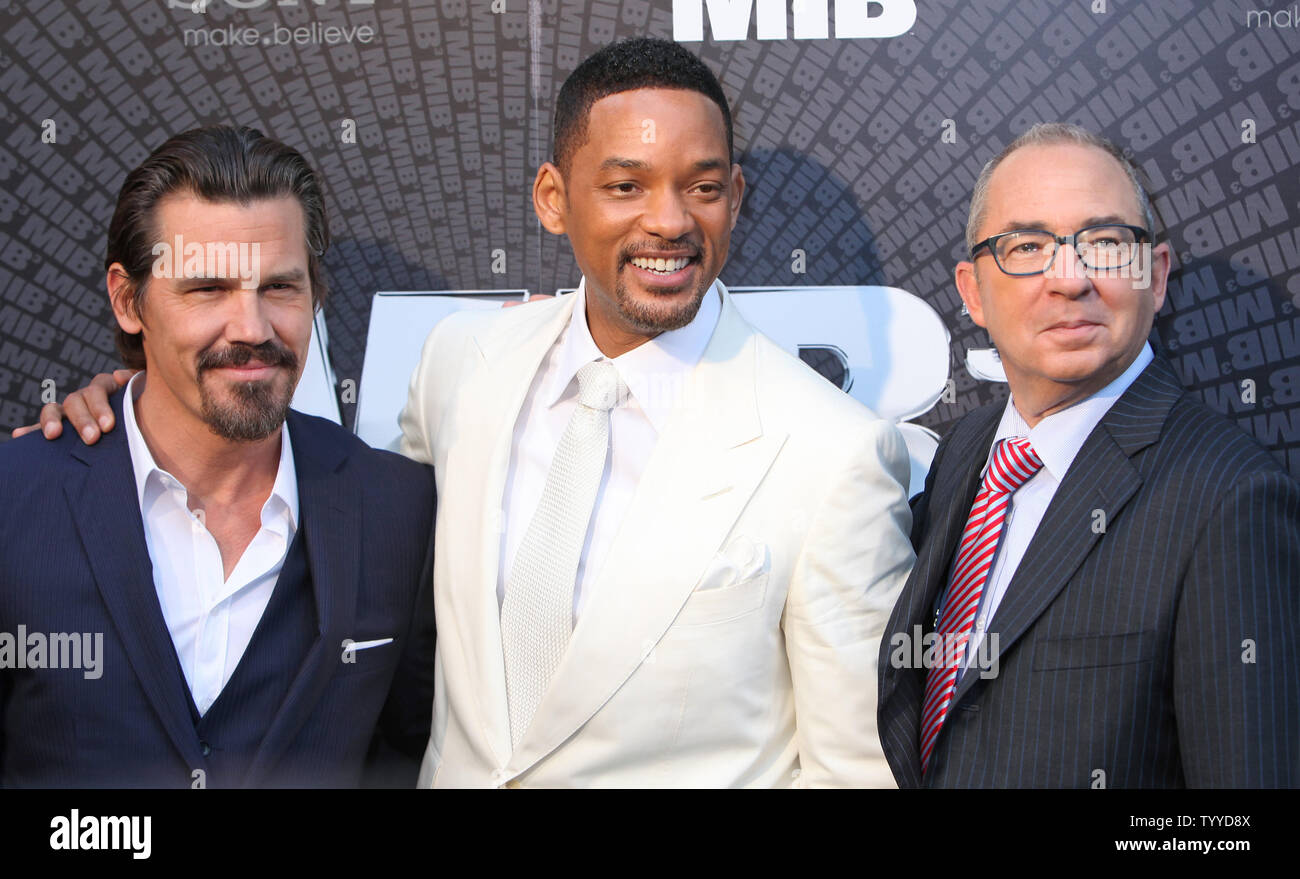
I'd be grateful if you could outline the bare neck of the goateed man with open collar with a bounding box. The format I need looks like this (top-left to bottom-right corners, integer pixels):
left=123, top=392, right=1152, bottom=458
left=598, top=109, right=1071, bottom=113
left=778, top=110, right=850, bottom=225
left=132, top=381, right=282, bottom=508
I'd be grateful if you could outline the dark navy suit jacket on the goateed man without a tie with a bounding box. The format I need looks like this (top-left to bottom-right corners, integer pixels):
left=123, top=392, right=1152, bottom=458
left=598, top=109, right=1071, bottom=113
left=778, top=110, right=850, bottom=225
left=0, top=393, right=434, bottom=787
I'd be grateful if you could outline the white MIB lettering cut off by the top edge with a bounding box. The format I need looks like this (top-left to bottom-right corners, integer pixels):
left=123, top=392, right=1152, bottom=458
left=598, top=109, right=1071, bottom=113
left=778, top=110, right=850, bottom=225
left=672, top=0, right=917, bottom=43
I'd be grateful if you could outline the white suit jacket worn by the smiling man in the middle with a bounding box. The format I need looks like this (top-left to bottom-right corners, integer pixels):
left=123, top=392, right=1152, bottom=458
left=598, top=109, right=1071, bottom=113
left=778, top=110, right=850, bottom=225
left=400, top=285, right=914, bottom=787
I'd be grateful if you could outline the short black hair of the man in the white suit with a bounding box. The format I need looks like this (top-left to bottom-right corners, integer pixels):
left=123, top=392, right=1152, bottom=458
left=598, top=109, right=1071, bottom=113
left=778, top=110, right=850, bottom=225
left=554, top=36, right=735, bottom=173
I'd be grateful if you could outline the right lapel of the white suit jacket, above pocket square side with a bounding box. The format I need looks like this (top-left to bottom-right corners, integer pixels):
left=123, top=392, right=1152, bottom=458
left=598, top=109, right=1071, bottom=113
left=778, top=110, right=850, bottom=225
left=507, top=286, right=785, bottom=775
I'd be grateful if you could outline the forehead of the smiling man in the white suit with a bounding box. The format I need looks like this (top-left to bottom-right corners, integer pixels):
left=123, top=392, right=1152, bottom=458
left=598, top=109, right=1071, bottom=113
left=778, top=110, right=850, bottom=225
left=573, top=88, right=727, bottom=170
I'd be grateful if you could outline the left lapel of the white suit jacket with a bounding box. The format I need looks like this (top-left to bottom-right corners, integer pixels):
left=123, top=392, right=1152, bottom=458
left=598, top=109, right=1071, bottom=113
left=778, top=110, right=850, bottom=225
left=438, top=295, right=577, bottom=765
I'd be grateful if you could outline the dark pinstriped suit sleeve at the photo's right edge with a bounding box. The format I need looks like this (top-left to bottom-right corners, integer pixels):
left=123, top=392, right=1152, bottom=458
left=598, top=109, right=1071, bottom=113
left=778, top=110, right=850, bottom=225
left=1174, top=471, right=1300, bottom=788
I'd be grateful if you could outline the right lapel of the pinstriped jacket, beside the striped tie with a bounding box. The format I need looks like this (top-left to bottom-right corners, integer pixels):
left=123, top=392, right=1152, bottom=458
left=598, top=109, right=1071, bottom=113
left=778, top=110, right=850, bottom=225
left=953, top=358, right=1183, bottom=705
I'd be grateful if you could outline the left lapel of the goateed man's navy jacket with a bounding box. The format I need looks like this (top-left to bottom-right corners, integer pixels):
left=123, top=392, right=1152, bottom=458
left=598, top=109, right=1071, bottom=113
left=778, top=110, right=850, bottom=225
left=64, top=393, right=204, bottom=766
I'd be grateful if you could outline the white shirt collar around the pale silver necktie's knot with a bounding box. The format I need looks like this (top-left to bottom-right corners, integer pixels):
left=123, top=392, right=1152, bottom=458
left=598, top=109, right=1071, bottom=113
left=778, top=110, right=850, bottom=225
left=541, top=278, right=722, bottom=434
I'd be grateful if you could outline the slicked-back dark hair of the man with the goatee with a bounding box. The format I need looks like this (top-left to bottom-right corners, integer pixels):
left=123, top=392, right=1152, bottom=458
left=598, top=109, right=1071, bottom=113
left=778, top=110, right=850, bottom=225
left=104, top=125, right=329, bottom=369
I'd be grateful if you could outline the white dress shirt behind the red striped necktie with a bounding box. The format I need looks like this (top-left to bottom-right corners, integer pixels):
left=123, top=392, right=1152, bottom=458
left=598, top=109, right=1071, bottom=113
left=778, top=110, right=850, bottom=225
left=965, top=343, right=1153, bottom=668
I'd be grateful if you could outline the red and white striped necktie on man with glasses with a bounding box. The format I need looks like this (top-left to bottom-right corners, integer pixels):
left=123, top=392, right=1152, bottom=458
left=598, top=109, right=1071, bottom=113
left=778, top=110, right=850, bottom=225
left=920, top=437, right=1043, bottom=772
